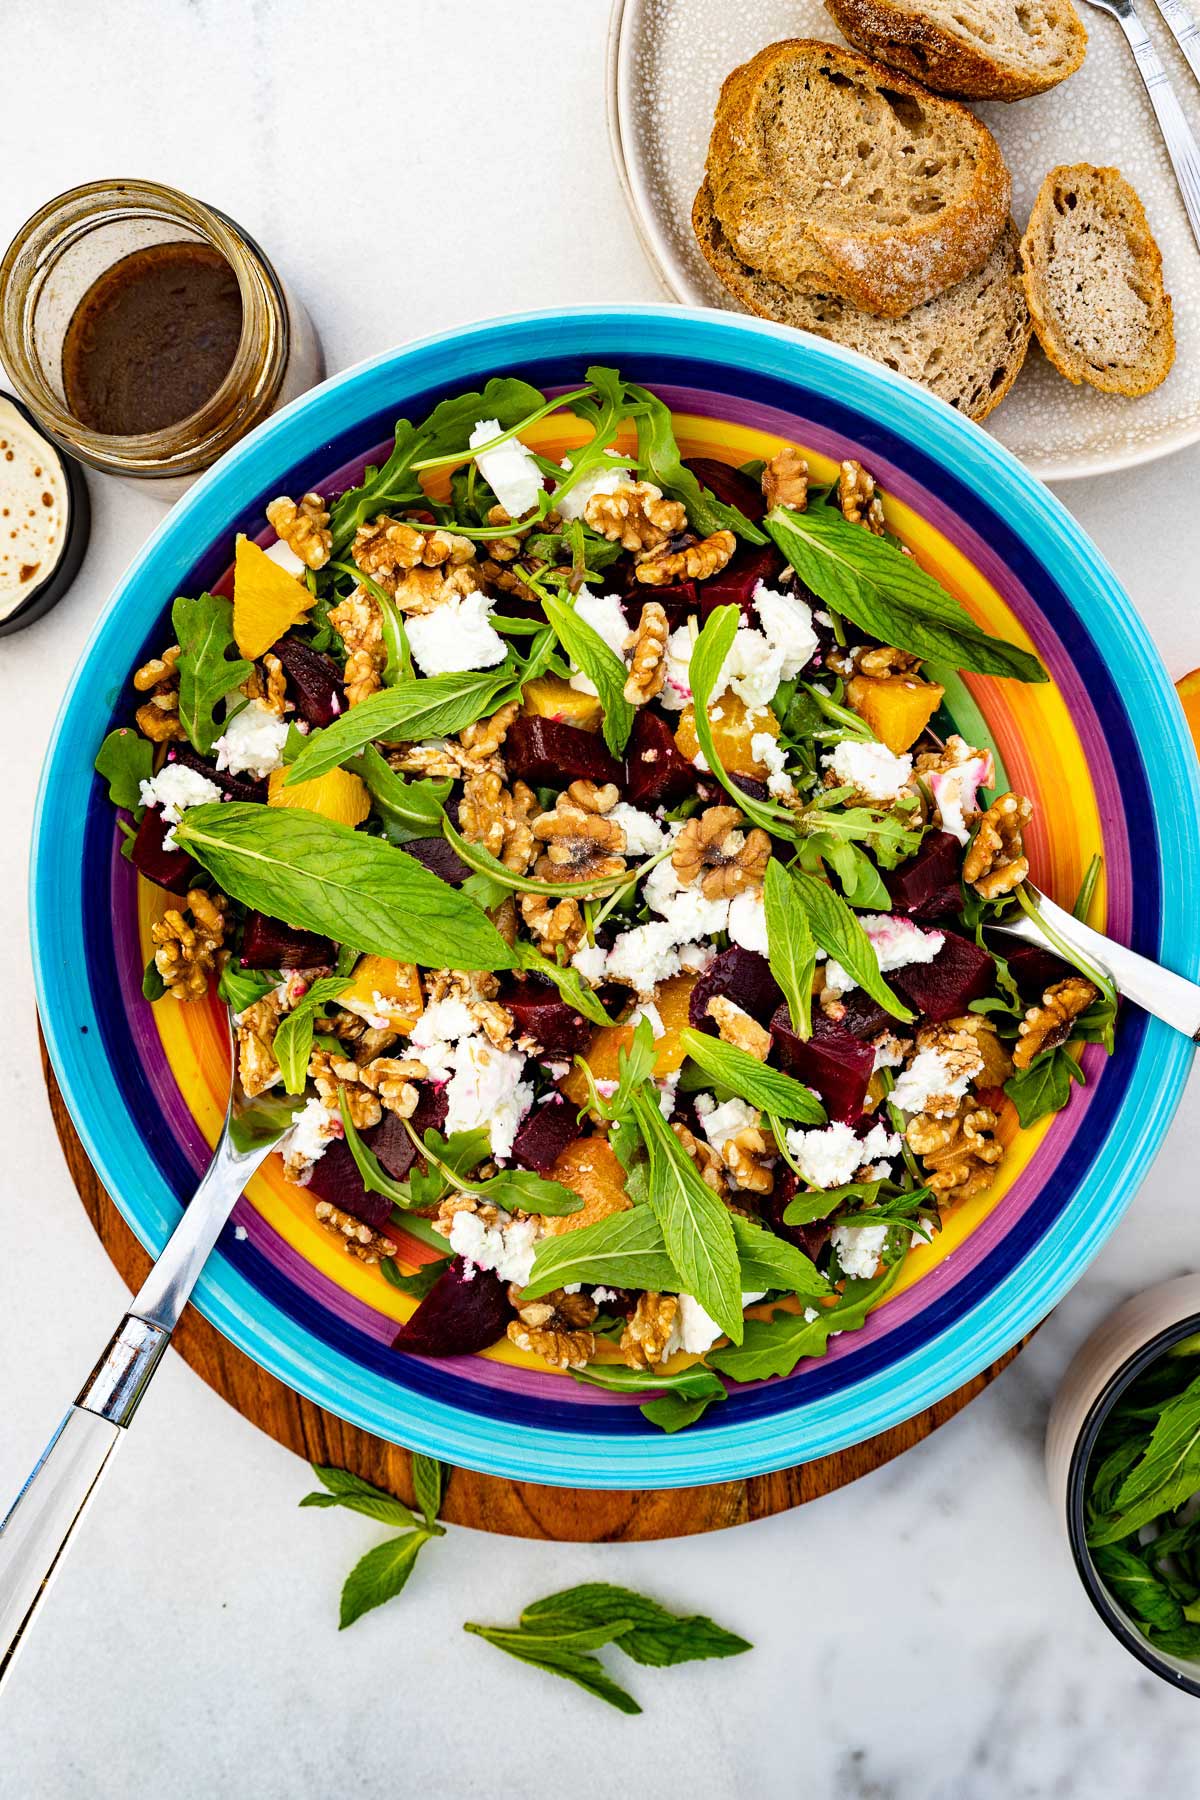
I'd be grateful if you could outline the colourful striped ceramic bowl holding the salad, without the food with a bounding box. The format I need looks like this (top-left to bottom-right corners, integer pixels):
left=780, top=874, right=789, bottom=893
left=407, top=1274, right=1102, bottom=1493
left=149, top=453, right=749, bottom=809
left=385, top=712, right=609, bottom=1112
left=31, top=306, right=1200, bottom=1487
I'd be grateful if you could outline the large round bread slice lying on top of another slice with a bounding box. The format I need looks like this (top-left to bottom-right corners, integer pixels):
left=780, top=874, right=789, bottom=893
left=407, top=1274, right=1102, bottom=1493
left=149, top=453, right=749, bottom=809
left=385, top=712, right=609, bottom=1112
left=707, top=38, right=1011, bottom=317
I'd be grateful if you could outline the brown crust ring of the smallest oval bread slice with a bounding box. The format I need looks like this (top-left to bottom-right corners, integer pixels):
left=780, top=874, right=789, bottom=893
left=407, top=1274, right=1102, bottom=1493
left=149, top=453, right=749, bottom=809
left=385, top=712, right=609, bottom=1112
left=1020, top=162, right=1175, bottom=400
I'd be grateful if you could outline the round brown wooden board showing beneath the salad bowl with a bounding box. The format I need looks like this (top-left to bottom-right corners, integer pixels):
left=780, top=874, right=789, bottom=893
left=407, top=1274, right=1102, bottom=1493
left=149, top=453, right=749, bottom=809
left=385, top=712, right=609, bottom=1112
left=41, top=1044, right=1022, bottom=1543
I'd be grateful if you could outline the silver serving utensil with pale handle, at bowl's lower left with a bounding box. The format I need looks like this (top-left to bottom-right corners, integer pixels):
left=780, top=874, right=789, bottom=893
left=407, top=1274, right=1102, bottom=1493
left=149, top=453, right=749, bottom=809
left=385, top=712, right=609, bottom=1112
left=0, top=1015, right=299, bottom=1685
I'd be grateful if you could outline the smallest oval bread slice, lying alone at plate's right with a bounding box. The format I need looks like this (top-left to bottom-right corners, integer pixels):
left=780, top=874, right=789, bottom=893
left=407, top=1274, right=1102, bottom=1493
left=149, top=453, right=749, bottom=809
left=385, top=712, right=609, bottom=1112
left=1020, top=162, right=1175, bottom=394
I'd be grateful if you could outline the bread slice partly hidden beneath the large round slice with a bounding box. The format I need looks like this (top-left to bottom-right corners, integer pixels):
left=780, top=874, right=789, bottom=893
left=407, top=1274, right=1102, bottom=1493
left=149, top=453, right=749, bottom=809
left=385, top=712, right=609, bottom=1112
left=691, top=182, right=1031, bottom=419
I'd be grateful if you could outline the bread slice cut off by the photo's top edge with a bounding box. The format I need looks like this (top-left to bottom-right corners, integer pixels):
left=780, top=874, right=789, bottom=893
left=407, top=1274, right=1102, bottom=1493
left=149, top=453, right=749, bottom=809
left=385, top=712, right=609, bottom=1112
left=826, top=0, right=1087, bottom=101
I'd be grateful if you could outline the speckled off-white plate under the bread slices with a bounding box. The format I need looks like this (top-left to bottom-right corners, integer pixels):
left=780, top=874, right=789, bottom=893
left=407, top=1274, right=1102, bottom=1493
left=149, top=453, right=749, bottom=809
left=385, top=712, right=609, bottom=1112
left=608, top=0, right=1200, bottom=481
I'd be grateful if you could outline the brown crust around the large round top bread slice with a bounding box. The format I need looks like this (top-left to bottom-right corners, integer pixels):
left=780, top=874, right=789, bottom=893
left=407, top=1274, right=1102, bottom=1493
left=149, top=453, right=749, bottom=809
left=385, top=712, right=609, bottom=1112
left=707, top=38, right=1013, bottom=317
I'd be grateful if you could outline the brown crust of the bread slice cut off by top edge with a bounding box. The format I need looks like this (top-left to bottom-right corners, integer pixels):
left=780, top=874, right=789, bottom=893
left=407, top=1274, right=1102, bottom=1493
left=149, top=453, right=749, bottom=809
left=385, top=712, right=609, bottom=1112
left=824, top=0, right=1087, bottom=101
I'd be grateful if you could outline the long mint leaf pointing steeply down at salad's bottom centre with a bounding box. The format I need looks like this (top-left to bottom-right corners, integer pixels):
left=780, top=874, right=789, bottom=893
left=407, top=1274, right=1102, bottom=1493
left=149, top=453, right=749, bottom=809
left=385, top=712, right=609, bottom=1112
left=630, top=1089, right=745, bottom=1343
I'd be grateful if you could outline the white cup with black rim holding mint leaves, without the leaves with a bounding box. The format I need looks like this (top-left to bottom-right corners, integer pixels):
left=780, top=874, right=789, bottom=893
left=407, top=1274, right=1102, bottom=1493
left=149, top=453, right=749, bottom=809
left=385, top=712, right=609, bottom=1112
left=1045, top=1274, right=1200, bottom=1696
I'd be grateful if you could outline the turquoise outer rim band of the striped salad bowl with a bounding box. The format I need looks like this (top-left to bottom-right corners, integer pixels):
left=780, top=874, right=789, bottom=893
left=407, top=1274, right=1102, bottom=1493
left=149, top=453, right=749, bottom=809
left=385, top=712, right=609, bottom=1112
left=31, top=306, right=1200, bottom=1489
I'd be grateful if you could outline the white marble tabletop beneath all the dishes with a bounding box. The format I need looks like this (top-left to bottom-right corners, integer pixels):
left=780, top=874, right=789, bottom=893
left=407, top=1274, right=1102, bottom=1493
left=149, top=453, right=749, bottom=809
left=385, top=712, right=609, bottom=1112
left=0, top=0, right=1200, bottom=1800
